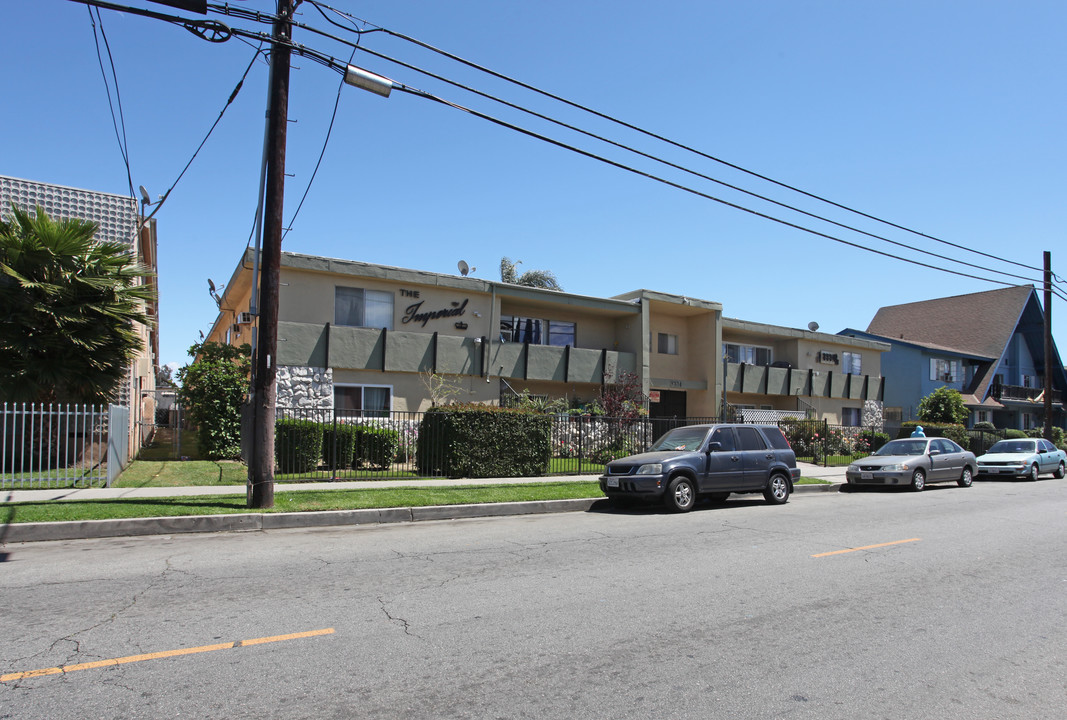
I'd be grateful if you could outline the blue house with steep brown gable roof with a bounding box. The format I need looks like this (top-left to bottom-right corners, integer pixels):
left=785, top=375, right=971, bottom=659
left=839, top=285, right=1067, bottom=430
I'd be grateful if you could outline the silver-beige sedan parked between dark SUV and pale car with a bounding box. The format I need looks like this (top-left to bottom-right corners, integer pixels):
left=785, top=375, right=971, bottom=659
left=845, top=437, right=977, bottom=491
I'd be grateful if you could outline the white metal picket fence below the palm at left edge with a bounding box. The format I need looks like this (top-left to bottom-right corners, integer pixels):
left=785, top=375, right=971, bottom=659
left=0, top=402, right=129, bottom=490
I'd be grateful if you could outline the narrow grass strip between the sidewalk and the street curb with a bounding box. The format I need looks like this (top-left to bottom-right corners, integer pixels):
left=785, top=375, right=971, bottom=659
left=0, top=482, right=604, bottom=523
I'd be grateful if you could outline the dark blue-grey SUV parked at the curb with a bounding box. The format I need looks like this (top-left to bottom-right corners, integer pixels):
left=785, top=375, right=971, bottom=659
left=600, top=425, right=800, bottom=512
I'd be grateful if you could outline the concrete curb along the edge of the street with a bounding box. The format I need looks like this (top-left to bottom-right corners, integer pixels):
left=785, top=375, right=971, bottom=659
left=0, top=483, right=841, bottom=545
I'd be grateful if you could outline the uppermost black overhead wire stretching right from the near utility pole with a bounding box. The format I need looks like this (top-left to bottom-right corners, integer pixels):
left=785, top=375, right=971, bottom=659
left=307, top=0, right=1064, bottom=282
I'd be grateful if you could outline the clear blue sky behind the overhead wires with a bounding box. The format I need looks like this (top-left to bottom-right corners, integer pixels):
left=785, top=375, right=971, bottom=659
left=0, top=0, right=1067, bottom=377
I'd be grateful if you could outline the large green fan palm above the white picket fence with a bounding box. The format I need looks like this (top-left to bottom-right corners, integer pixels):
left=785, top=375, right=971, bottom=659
left=0, top=204, right=155, bottom=402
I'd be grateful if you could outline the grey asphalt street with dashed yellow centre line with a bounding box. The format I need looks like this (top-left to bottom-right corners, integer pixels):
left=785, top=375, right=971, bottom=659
left=0, top=480, right=1067, bottom=720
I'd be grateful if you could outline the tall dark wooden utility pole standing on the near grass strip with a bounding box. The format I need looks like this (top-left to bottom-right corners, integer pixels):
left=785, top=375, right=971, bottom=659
left=248, top=0, right=294, bottom=508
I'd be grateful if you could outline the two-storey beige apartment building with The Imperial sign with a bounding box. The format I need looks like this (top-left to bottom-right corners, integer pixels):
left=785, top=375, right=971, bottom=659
left=207, top=251, right=888, bottom=425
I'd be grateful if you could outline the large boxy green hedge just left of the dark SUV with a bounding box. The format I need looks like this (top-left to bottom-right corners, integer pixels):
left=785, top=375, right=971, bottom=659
left=417, top=405, right=552, bottom=478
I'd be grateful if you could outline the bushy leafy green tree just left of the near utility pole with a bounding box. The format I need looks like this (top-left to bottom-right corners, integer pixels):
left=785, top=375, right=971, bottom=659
left=178, top=342, right=253, bottom=460
